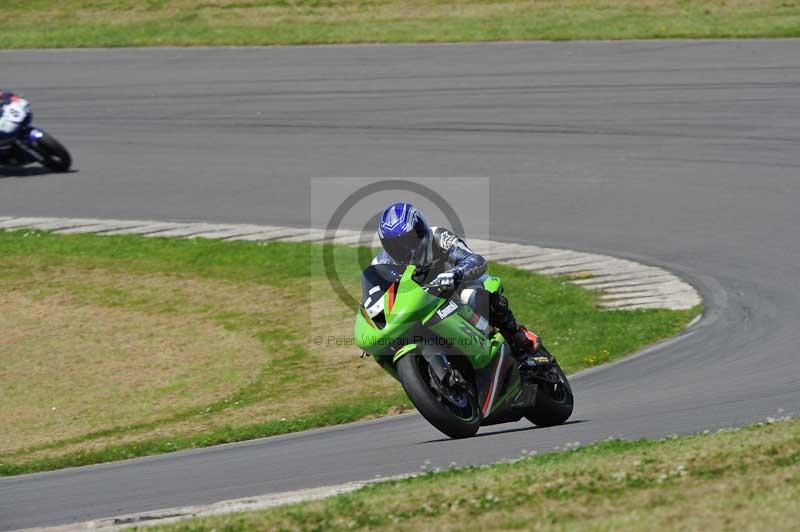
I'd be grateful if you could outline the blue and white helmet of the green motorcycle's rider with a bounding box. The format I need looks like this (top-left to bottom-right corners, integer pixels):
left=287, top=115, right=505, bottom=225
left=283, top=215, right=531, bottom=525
left=378, top=202, right=430, bottom=266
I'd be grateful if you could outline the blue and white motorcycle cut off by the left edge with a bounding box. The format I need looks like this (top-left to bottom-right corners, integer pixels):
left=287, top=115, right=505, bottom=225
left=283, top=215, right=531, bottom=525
left=0, top=93, right=72, bottom=172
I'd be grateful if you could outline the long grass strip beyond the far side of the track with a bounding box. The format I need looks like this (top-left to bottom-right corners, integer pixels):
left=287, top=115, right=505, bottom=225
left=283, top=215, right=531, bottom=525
left=0, top=0, right=800, bottom=48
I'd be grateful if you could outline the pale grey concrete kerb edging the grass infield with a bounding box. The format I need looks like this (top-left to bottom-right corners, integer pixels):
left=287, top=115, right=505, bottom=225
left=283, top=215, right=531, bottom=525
left=0, top=216, right=702, bottom=310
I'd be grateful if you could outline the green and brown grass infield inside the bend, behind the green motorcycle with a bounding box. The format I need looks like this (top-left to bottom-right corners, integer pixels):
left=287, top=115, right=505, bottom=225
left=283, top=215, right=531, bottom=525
left=0, top=231, right=698, bottom=475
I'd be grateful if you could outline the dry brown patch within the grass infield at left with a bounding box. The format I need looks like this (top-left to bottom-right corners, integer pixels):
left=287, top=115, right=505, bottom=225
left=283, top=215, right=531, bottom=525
left=0, top=271, right=276, bottom=451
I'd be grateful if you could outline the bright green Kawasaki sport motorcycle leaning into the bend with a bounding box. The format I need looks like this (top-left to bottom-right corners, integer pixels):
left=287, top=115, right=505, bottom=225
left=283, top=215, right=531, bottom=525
left=355, top=265, right=574, bottom=438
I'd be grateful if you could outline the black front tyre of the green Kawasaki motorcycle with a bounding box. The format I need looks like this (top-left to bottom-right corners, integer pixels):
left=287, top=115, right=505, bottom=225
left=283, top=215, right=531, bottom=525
left=397, top=353, right=481, bottom=438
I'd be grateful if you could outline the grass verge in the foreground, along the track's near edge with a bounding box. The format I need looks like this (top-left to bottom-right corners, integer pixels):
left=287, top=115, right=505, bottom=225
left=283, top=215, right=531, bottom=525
left=147, top=420, right=800, bottom=532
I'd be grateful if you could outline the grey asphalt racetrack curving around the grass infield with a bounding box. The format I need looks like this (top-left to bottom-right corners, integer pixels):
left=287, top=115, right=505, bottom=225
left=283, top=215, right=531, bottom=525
left=0, top=40, right=800, bottom=529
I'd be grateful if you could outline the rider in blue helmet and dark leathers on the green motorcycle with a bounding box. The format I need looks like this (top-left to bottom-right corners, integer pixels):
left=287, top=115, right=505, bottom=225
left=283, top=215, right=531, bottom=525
left=372, top=202, right=540, bottom=362
